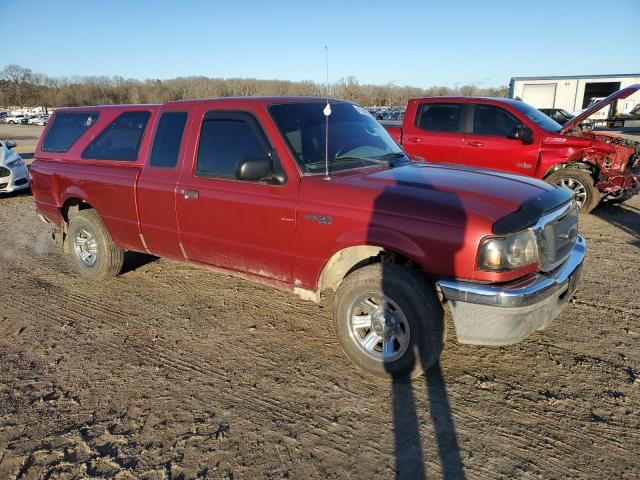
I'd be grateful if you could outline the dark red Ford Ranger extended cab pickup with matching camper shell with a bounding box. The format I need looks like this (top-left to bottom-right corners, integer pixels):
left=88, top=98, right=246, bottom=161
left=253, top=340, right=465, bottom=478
left=31, top=98, right=585, bottom=377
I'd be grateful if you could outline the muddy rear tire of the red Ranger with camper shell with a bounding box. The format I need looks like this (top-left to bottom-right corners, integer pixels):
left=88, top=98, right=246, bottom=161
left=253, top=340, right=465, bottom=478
left=68, top=210, right=124, bottom=280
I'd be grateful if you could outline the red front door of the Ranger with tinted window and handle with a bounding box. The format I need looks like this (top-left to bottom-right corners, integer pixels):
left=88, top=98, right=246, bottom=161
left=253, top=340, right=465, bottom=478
left=176, top=105, right=297, bottom=283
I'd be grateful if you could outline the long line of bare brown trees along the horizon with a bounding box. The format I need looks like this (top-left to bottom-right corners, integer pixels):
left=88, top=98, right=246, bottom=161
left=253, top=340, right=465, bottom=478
left=0, top=65, right=508, bottom=107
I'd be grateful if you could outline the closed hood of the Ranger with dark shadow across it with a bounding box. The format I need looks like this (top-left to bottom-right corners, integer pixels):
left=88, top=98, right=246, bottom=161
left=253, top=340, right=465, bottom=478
left=335, top=163, right=566, bottom=225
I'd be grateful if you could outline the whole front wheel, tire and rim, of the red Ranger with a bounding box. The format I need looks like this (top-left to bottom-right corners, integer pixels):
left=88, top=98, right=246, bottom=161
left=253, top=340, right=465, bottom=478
left=333, top=263, right=444, bottom=380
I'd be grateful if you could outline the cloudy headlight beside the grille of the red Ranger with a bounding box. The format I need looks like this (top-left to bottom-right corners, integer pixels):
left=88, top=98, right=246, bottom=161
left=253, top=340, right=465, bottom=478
left=478, top=230, right=538, bottom=272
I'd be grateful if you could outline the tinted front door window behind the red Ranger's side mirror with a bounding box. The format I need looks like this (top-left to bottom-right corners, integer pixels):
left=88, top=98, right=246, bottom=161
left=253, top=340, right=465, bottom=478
left=196, top=112, right=275, bottom=179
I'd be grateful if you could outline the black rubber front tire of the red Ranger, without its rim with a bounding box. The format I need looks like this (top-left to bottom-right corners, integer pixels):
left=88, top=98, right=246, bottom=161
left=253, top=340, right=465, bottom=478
left=333, top=263, right=444, bottom=380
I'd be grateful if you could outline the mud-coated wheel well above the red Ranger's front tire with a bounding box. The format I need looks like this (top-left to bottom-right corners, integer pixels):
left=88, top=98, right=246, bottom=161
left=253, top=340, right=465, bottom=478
left=318, top=245, right=415, bottom=293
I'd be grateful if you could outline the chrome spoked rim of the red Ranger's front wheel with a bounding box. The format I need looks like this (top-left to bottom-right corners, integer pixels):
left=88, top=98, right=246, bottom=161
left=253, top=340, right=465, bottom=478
left=348, top=293, right=411, bottom=362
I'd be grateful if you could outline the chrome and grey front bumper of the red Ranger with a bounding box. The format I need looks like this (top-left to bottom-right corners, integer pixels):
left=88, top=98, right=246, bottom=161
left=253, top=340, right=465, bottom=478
left=438, top=237, right=586, bottom=345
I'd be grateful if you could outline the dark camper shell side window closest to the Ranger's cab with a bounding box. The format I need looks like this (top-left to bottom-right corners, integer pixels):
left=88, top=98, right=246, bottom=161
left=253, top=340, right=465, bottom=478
left=82, top=112, right=150, bottom=162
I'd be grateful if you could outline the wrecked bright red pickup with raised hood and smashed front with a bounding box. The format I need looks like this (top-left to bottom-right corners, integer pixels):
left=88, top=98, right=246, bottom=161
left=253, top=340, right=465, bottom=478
left=385, top=84, right=640, bottom=213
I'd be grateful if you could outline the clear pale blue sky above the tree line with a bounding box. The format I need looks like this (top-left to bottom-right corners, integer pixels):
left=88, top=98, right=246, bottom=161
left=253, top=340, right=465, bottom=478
left=0, top=0, right=640, bottom=87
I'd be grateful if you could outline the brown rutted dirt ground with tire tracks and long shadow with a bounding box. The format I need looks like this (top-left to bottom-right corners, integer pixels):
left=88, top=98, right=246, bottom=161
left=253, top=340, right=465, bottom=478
left=0, top=125, right=640, bottom=480
